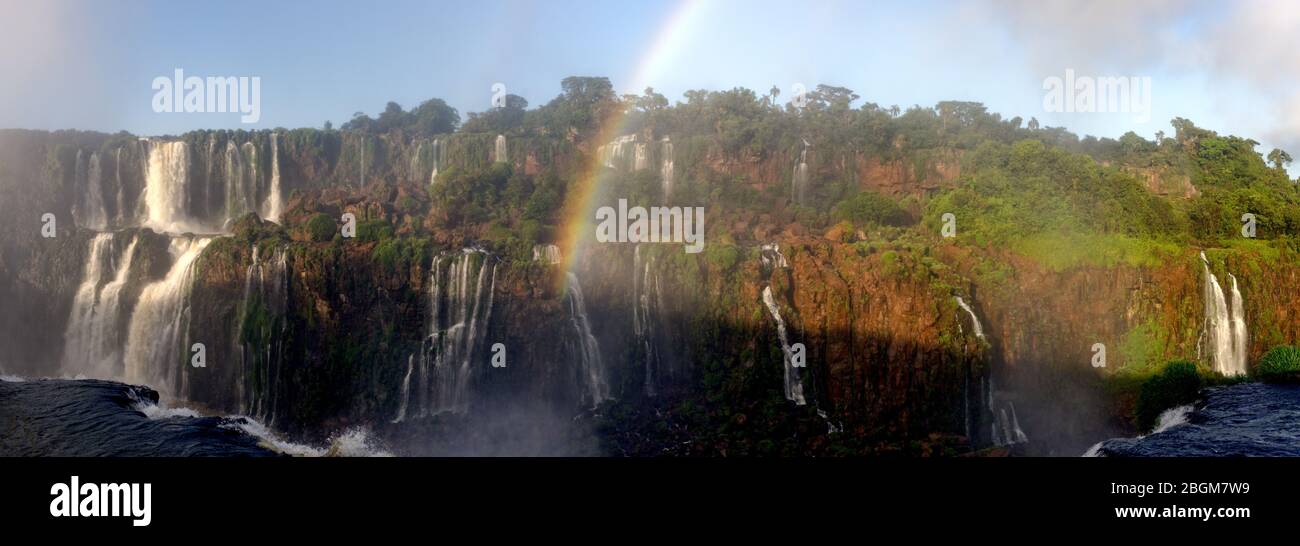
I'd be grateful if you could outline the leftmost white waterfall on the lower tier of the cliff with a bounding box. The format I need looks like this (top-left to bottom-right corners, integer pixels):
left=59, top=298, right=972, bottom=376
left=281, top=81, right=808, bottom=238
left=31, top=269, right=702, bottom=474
left=61, top=233, right=137, bottom=378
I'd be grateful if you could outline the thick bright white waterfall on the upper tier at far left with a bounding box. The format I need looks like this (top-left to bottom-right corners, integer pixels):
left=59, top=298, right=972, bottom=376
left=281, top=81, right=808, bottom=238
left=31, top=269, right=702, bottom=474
left=144, top=140, right=195, bottom=233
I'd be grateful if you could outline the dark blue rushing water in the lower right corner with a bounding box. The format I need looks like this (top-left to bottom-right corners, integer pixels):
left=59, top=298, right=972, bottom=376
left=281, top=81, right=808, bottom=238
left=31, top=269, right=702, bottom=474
left=1086, top=384, right=1300, bottom=456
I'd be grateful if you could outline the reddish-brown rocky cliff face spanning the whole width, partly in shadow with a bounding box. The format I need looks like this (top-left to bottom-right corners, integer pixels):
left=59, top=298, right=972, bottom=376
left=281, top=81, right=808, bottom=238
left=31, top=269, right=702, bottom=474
left=0, top=126, right=1300, bottom=455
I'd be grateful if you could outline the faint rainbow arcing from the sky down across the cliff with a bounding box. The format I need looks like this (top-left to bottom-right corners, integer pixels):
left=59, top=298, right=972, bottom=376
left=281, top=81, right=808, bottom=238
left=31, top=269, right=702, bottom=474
left=559, top=0, right=705, bottom=282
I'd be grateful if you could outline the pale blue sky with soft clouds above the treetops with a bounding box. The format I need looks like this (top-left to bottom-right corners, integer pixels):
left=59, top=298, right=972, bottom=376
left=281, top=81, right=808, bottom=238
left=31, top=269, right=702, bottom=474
left=0, top=0, right=1300, bottom=170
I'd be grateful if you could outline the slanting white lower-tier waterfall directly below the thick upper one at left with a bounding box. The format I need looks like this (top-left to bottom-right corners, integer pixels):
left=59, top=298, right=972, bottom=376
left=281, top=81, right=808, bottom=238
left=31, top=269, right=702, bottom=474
left=126, top=237, right=212, bottom=393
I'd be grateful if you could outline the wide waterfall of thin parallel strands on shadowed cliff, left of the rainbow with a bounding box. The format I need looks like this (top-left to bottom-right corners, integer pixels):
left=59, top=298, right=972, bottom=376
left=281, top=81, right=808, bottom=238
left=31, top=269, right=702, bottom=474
left=413, top=248, right=497, bottom=420
